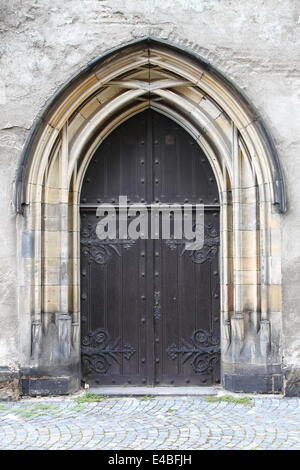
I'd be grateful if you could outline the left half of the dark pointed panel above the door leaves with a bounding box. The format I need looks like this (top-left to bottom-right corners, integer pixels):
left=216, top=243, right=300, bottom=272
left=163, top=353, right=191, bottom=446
left=81, top=115, right=151, bottom=204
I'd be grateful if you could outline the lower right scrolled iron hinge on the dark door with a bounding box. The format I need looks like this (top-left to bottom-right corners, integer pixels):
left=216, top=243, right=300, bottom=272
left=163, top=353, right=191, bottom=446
left=166, top=330, right=220, bottom=374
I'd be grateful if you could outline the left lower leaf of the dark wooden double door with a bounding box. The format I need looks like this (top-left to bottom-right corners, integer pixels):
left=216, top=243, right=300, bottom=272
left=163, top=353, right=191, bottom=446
left=81, top=210, right=152, bottom=385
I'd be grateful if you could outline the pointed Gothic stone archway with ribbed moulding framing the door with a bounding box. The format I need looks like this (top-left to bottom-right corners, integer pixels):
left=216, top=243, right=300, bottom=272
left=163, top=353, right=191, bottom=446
left=16, top=38, right=285, bottom=394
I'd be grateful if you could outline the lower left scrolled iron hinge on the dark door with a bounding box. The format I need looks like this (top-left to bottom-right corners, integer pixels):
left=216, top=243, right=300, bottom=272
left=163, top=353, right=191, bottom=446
left=81, top=329, right=136, bottom=375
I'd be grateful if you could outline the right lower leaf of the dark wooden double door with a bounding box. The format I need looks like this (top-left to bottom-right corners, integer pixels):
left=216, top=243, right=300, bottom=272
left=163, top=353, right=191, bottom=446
left=155, top=211, right=220, bottom=385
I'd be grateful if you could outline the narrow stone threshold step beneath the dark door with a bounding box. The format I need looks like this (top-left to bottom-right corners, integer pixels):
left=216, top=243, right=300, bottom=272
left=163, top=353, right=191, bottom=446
left=86, top=386, right=219, bottom=397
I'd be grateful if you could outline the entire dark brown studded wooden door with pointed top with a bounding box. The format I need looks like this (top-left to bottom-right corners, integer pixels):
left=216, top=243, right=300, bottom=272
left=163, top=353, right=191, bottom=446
left=81, top=110, right=220, bottom=385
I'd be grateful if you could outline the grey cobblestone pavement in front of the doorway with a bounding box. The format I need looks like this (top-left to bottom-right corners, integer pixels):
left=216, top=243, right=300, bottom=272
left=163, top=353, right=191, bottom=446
left=0, top=397, right=300, bottom=450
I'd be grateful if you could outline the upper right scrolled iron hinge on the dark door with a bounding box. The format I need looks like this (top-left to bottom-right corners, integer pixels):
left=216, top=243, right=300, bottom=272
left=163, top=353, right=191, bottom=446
left=165, top=223, right=220, bottom=264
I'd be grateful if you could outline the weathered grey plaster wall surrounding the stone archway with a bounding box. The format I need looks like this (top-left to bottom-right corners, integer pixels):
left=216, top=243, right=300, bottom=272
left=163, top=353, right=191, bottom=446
left=0, top=0, right=300, bottom=393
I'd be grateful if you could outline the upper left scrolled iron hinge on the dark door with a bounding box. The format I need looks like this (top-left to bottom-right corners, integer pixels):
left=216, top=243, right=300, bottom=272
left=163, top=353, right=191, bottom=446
left=80, top=222, right=136, bottom=264
